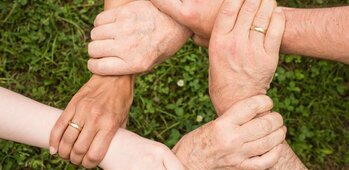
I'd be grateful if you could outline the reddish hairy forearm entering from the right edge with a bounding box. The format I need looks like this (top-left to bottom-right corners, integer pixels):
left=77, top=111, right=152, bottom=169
left=281, top=7, right=349, bottom=64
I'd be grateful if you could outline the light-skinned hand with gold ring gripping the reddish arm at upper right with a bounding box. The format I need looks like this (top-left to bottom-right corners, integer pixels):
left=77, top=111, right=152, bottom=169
left=209, top=0, right=285, bottom=115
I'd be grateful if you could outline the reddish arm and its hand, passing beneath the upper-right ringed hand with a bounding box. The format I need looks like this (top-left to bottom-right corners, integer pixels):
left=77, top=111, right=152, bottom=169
left=151, top=0, right=349, bottom=64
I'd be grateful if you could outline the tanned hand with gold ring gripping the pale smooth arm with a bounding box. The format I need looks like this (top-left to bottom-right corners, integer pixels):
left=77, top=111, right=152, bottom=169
left=50, top=75, right=133, bottom=168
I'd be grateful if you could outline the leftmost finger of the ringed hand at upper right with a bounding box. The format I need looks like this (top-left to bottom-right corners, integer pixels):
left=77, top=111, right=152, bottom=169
left=213, top=0, right=243, bottom=35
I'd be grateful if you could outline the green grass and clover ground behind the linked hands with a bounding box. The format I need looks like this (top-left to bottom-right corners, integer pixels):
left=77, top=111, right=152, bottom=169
left=0, top=0, right=349, bottom=169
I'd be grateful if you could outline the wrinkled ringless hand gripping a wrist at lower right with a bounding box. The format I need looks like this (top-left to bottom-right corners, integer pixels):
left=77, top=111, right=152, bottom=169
left=173, top=96, right=286, bottom=169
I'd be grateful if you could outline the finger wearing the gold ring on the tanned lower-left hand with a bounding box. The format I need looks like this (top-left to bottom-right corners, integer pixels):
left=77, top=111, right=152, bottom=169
left=58, top=111, right=84, bottom=159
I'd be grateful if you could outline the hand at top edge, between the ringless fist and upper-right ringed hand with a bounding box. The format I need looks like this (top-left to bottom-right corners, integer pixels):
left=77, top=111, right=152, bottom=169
left=151, top=0, right=223, bottom=47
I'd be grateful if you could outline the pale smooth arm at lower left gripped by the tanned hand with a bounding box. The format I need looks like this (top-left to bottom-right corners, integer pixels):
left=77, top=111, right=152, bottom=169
left=0, top=87, right=182, bottom=170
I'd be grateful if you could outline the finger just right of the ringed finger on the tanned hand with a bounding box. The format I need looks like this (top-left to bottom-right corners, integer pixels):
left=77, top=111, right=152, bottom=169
left=70, top=123, right=97, bottom=165
